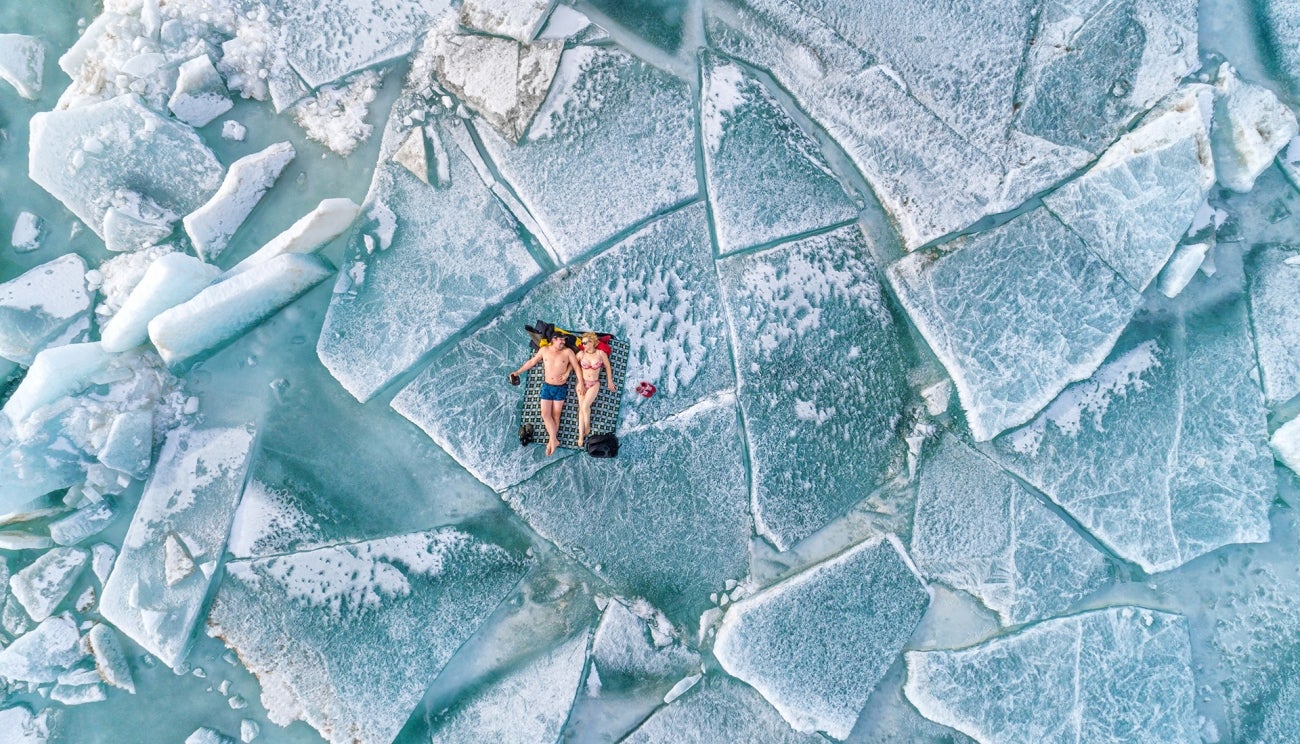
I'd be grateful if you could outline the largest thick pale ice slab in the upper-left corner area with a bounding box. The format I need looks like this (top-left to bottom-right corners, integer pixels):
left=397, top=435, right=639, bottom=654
left=29, top=95, right=222, bottom=237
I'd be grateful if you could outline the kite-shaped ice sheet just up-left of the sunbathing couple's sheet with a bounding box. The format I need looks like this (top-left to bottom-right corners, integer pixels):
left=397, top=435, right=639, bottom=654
left=317, top=122, right=541, bottom=402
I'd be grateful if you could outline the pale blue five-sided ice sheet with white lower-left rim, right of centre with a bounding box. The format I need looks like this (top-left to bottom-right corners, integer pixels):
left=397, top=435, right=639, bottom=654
left=888, top=209, right=1141, bottom=441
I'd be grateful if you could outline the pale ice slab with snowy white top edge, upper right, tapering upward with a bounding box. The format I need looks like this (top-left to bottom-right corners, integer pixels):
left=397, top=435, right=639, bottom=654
left=1043, top=86, right=1214, bottom=291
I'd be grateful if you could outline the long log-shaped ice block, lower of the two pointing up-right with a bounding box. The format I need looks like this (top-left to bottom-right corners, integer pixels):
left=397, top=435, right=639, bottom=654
left=148, top=254, right=334, bottom=364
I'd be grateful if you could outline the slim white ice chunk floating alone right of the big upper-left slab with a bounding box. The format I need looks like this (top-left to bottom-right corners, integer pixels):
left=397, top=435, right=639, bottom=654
left=183, top=142, right=296, bottom=261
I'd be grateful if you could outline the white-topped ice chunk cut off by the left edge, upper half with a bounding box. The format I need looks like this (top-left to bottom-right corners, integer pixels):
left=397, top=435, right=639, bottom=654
left=0, top=254, right=91, bottom=364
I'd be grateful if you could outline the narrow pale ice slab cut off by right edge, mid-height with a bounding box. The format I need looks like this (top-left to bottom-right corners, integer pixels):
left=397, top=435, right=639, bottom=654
left=1247, top=246, right=1300, bottom=405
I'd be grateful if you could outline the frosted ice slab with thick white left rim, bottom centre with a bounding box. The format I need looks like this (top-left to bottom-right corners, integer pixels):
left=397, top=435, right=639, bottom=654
left=714, top=538, right=930, bottom=739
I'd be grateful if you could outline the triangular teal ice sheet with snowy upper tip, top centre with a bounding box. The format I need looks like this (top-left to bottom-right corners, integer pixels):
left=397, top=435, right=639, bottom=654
left=699, top=52, right=858, bottom=255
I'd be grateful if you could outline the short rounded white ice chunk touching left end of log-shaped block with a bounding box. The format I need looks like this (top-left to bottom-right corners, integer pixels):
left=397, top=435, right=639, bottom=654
left=100, top=254, right=221, bottom=351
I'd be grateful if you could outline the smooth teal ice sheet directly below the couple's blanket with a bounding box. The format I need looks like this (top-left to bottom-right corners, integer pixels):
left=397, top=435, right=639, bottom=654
left=503, top=397, right=750, bottom=624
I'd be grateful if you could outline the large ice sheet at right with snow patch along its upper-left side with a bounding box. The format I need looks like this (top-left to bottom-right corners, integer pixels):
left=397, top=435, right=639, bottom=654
left=987, top=300, right=1277, bottom=572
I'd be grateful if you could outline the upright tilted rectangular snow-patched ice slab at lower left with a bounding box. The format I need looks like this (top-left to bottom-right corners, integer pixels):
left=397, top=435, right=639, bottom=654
left=99, top=428, right=254, bottom=667
